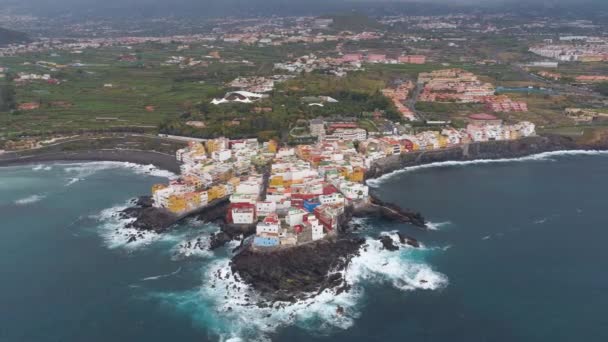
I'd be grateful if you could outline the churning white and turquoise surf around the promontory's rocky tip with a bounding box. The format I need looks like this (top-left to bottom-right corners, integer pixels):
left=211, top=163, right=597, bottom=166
left=161, top=233, right=448, bottom=341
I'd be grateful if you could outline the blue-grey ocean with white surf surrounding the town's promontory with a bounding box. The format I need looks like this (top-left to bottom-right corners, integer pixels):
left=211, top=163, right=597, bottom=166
left=0, top=152, right=608, bottom=342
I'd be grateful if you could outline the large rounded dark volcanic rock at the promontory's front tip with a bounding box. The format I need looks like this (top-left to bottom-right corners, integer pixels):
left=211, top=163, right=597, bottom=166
left=231, top=237, right=365, bottom=301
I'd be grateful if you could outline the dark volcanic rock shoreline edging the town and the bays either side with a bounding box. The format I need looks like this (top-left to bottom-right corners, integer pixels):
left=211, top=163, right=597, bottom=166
left=5, top=135, right=608, bottom=302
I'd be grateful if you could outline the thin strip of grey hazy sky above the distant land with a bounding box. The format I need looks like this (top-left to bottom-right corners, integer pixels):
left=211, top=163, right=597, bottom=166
left=0, top=0, right=608, bottom=16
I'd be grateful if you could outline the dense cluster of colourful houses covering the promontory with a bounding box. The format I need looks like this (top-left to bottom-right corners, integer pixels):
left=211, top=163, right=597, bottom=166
left=152, top=113, right=535, bottom=249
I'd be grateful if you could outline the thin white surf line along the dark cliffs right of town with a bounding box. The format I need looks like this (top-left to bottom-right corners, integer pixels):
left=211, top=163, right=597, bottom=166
left=366, top=150, right=608, bottom=188
